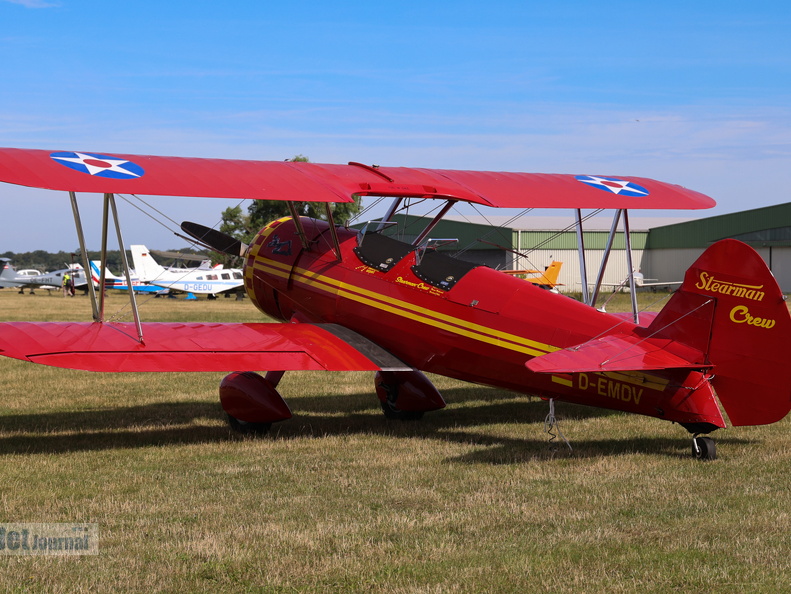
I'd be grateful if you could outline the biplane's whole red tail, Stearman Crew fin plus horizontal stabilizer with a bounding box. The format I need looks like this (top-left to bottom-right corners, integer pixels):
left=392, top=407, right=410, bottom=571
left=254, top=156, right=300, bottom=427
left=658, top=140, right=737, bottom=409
left=526, top=239, right=791, bottom=425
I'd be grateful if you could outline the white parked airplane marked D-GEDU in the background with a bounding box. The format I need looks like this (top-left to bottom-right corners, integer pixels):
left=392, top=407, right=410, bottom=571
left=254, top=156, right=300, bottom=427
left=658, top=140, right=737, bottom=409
left=129, top=245, right=244, bottom=295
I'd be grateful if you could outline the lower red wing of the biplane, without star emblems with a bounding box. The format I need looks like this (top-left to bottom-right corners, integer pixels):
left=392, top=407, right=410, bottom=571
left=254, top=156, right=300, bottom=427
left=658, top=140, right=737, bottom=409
left=0, top=322, right=411, bottom=371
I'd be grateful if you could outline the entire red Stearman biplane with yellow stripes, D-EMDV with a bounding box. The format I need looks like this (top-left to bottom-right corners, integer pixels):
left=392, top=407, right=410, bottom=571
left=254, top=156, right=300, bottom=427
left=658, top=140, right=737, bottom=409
left=0, top=149, right=791, bottom=459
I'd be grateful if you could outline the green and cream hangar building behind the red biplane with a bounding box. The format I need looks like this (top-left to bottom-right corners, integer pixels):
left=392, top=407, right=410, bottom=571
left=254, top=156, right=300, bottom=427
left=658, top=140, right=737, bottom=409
left=370, top=203, right=791, bottom=292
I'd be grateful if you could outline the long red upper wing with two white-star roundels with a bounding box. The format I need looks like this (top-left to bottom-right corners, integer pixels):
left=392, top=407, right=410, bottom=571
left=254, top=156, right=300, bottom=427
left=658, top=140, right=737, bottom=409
left=0, top=148, right=714, bottom=209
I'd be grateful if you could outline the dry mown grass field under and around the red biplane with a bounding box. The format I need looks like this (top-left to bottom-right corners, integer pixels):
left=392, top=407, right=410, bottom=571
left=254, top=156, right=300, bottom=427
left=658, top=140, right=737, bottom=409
left=0, top=289, right=791, bottom=593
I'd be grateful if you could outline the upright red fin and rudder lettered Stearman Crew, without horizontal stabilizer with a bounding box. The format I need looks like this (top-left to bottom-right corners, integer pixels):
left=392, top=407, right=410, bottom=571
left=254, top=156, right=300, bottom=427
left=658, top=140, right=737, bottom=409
left=647, top=239, right=791, bottom=425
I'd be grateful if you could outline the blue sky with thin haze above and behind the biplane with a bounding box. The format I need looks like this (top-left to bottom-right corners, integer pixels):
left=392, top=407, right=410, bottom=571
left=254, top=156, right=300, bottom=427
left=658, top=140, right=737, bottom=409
left=0, top=0, right=791, bottom=252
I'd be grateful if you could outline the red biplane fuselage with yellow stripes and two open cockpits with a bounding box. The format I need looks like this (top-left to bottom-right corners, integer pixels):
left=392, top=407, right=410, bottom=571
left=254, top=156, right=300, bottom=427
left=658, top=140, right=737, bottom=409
left=245, top=218, right=724, bottom=427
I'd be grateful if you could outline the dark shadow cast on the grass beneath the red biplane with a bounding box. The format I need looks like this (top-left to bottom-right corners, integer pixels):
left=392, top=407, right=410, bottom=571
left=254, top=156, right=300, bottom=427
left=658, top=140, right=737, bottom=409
left=0, top=386, right=748, bottom=464
